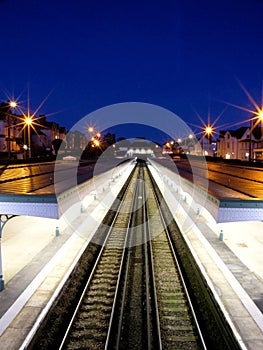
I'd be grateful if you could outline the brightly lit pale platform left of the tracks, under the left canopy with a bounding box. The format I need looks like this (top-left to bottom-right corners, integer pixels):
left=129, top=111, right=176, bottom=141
left=0, top=160, right=136, bottom=350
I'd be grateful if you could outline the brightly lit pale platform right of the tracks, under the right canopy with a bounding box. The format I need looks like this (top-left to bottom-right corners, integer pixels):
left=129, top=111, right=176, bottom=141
left=151, top=167, right=263, bottom=350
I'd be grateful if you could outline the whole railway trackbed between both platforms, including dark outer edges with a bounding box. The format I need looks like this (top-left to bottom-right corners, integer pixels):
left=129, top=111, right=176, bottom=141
left=28, top=162, right=243, bottom=350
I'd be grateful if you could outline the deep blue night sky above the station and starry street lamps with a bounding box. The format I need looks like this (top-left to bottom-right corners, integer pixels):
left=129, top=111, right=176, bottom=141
left=0, top=0, right=263, bottom=142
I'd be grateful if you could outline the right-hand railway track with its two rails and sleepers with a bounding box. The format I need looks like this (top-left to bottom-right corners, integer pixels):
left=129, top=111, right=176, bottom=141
left=146, top=168, right=206, bottom=349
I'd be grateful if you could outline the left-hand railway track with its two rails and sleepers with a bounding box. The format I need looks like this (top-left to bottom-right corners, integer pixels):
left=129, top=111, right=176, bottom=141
left=60, top=165, right=138, bottom=349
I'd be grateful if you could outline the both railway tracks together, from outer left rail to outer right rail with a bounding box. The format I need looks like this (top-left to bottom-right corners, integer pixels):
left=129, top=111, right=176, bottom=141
left=57, top=164, right=206, bottom=349
